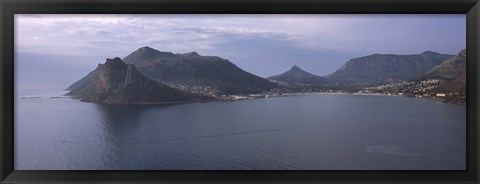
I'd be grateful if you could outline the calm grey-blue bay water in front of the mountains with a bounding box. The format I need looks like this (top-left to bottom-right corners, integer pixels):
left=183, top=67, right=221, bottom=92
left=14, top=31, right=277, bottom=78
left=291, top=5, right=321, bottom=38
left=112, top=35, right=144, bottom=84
left=15, top=89, right=466, bottom=170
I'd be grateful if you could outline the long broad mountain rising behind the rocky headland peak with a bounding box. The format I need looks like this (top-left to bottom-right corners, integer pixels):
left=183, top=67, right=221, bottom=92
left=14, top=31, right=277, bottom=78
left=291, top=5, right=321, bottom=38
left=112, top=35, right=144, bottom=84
left=123, top=47, right=277, bottom=94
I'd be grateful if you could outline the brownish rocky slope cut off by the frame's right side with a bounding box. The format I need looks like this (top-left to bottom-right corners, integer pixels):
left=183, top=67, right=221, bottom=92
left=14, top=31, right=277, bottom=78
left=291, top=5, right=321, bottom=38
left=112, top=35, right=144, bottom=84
left=420, top=49, right=467, bottom=80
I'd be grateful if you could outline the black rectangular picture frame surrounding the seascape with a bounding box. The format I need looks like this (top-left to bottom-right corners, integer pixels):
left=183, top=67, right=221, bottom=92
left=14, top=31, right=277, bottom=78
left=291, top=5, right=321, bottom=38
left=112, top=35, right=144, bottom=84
left=0, top=0, right=480, bottom=183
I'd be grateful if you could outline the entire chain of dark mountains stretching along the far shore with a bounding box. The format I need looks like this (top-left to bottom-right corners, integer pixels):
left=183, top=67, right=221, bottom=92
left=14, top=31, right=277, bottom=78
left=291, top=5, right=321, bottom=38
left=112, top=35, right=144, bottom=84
left=67, top=47, right=466, bottom=104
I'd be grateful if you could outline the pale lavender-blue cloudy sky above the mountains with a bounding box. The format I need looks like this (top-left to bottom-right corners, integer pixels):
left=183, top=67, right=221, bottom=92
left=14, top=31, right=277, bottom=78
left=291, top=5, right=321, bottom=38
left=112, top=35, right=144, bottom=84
left=15, top=14, right=466, bottom=85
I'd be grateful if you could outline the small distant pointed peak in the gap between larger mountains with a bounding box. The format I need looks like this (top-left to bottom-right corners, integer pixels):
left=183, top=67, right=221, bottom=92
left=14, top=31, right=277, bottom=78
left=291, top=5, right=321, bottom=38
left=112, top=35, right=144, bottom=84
left=267, top=65, right=331, bottom=87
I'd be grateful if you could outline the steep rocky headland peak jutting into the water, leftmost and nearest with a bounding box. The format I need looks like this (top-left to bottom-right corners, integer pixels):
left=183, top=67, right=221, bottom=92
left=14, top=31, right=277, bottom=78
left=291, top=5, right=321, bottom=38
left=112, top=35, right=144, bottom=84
left=67, top=58, right=203, bottom=104
